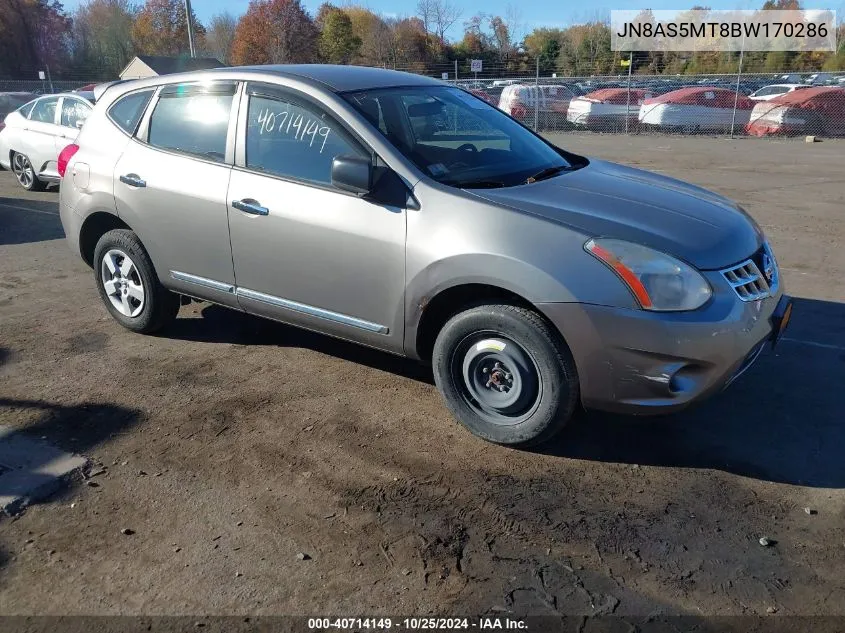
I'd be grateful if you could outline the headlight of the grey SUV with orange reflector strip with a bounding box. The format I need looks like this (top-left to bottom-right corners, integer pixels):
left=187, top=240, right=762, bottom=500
left=584, top=238, right=713, bottom=311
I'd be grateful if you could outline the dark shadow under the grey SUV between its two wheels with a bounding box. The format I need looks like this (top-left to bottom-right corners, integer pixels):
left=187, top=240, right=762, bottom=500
left=160, top=304, right=434, bottom=385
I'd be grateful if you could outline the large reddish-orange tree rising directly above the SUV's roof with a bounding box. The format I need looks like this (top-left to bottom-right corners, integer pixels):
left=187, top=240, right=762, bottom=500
left=232, top=0, right=318, bottom=65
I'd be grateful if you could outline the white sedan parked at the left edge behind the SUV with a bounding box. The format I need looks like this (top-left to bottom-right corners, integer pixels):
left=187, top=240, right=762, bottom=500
left=0, top=92, right=94, bottom=191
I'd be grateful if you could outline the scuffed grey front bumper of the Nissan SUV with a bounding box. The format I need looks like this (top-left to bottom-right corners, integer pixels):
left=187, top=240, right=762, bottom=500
left=539, top=276, right=789, bottom=414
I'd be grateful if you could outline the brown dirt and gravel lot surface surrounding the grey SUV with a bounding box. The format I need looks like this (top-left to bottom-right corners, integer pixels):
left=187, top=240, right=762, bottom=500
left=0, top=135, right=845, bottom=615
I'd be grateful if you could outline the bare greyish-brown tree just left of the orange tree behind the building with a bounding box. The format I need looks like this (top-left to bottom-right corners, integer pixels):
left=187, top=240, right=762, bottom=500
left=72, top=0, right=135, bottom=77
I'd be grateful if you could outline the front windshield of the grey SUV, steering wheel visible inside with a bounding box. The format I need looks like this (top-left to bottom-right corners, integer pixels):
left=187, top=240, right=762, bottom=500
left=344, top=86, right=583, bottom=188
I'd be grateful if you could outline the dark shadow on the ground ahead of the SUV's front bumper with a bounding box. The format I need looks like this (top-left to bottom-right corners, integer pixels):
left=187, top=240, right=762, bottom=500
left=541, top=299, right=845, bottom=488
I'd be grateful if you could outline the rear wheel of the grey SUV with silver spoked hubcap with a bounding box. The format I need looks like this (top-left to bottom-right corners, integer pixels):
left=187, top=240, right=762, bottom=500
left=94, top=229, right=180, bottom=334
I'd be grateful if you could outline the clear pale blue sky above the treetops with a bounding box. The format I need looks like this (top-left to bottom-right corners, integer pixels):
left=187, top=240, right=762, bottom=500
left=63, top=0, right=845, bottom=40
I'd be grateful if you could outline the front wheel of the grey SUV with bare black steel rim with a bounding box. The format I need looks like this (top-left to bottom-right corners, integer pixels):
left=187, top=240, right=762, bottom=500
left=432, top=304, right=578, bottom=446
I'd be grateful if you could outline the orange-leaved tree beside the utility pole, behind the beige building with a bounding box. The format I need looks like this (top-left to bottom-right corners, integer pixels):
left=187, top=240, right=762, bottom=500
left=132, top=0, right=205, bottom=56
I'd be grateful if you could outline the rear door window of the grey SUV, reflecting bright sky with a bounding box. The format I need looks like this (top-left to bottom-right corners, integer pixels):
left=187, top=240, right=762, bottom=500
left=147, top=84, right=235, bottom=162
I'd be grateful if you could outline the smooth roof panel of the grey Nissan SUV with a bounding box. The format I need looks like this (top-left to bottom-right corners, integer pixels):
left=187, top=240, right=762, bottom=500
left=218, top=64, right=442, bottom=92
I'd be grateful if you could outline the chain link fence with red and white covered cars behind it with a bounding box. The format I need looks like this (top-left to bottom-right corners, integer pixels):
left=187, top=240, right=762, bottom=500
left=0, top=68, right=845, bottom=137
